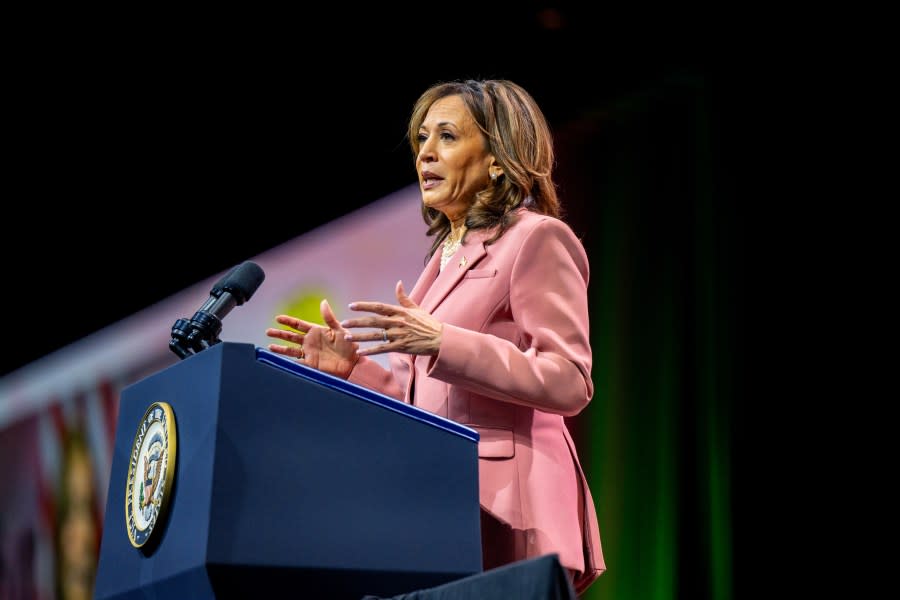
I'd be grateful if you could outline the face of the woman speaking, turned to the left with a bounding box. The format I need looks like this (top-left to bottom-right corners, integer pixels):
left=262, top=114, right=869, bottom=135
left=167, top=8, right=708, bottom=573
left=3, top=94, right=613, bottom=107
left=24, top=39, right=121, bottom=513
left=416, top=96, right=494, bottom=221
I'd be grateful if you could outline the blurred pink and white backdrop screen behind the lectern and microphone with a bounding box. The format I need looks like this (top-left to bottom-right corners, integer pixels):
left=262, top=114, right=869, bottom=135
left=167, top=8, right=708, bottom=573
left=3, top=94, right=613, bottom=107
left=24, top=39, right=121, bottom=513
left=0, top=185, right=430, bottom=600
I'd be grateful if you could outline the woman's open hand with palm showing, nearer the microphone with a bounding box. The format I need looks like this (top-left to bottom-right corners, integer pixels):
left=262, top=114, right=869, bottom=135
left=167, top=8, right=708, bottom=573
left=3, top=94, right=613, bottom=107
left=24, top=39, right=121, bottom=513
left=266, top=300, right=359, bottom=379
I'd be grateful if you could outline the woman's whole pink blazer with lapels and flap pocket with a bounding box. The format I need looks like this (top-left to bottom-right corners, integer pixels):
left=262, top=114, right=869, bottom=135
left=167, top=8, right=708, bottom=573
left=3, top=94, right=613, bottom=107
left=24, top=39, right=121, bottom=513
left=349, top=209, right=606, bottom=591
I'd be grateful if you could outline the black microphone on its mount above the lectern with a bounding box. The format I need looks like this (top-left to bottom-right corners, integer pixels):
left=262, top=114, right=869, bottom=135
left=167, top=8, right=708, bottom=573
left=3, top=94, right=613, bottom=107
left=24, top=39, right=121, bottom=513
left=169, top=261, right=266, bottom=359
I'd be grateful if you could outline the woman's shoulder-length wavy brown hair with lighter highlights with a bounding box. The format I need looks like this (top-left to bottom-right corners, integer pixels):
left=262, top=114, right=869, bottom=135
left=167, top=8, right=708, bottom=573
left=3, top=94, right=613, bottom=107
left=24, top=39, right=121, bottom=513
left=407, top=79, right=561, bottom=257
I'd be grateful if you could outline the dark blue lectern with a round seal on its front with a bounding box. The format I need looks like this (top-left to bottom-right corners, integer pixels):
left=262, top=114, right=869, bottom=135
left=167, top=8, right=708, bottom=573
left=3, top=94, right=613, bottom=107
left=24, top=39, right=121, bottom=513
left=95, top=342, right=481, bottom=600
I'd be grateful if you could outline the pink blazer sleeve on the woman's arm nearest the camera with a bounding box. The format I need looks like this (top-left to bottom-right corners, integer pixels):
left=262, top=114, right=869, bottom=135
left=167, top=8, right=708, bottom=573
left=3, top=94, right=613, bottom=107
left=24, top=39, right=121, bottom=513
left=429, top=218, right=594, bottom=416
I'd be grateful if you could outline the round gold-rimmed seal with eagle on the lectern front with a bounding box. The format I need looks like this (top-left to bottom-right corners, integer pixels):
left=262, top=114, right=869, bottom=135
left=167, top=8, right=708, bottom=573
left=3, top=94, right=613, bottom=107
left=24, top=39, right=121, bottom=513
left=125, top=402, right=177, bottom=548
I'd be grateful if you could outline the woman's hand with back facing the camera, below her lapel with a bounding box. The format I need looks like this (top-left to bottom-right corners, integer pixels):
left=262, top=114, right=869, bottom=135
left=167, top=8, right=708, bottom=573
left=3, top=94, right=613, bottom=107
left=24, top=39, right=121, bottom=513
left=341, top=281, right=444, bottom=356
